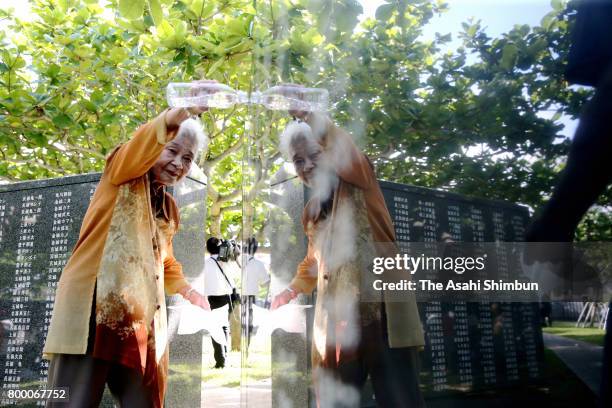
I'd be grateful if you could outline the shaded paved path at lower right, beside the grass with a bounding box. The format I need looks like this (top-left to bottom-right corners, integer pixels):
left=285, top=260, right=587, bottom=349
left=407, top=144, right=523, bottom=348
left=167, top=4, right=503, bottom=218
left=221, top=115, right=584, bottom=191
left=544, top=333, right=603, bottom=395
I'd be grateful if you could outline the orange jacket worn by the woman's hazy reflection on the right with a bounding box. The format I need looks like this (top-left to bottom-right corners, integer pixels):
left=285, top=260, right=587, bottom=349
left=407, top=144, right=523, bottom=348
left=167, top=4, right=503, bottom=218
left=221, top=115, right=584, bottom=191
left=290, top=114, right=425, bottom=348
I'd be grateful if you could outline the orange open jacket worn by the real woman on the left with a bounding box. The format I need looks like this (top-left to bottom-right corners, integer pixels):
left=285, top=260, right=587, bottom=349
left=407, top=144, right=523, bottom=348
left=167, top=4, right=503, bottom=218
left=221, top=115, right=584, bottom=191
left=43, top=112, right=187, bottom=358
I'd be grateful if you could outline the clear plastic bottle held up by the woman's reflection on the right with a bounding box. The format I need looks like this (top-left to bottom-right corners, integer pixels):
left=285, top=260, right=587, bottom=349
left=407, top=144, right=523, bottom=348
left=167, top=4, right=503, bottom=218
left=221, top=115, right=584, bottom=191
left=256, top=85, right=329, bottom=112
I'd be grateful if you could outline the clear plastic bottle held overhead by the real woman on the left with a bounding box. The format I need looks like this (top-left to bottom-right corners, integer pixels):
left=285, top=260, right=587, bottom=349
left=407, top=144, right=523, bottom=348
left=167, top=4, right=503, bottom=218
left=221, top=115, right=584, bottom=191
left=166, top=82, right=244, bottom=109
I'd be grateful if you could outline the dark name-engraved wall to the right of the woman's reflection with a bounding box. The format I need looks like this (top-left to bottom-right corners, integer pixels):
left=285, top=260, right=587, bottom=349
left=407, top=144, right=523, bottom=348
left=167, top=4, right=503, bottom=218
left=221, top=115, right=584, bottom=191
left=381, top=182, right=544, bottom=394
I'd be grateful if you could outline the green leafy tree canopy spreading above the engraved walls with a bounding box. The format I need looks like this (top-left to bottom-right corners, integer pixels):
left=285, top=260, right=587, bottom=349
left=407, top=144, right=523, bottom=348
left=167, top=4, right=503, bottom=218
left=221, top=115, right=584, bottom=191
left=0, top=0, right=612, bottom=239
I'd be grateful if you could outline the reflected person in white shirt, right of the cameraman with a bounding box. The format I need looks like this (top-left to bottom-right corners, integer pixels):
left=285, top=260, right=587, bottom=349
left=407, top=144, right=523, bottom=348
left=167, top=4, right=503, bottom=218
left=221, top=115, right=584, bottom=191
left=242, top=237, right=270, bottom=350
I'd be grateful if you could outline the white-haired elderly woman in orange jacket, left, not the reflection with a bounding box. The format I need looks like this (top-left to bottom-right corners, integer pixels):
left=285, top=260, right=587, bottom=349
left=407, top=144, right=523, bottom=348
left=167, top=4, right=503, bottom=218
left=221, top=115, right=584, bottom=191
left=43, top=108, right=209, bottom=408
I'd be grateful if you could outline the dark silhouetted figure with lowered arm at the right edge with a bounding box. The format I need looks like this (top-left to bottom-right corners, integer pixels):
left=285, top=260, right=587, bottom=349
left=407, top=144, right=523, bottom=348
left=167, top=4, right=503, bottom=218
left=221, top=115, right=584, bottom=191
left=525, top=0, right=612, bottom=407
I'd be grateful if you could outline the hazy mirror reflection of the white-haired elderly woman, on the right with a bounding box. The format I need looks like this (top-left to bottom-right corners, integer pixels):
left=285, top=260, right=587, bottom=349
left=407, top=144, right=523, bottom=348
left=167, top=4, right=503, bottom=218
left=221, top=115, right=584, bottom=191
left=272, top=112, right=424, bottom=408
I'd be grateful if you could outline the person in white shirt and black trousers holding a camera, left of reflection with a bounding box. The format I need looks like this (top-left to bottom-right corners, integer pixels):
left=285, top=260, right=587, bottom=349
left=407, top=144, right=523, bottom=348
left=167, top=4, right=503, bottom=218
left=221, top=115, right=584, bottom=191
left=204, top=237, right=233, bottom=368
